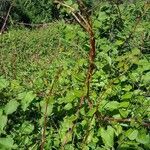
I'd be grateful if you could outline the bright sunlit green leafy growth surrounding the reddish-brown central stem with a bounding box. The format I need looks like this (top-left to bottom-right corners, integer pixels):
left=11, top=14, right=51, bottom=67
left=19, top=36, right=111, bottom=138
left=0, top=1, right=150, bottom=150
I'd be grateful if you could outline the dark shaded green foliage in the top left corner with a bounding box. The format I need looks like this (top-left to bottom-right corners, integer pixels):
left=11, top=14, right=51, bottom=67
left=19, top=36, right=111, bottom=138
left=0, top=0, right=59, bottom=26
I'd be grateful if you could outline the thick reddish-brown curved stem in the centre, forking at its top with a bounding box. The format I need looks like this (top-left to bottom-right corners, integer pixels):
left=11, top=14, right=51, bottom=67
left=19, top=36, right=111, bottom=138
left=55, top=0, right=96, bottom=147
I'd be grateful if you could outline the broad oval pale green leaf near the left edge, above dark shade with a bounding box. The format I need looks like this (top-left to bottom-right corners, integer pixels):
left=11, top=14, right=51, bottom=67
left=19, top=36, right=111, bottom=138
left=4, top=100, right=19, bottom=115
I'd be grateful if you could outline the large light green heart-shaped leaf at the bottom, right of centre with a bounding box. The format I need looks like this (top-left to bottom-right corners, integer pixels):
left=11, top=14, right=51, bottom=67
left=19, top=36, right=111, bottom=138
left=100, top=126, right=114, bottom=148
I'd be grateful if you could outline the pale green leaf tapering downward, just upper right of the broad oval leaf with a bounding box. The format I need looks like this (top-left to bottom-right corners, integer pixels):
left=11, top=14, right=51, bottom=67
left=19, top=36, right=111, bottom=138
left=18, top=91, right=36, bottom=111
